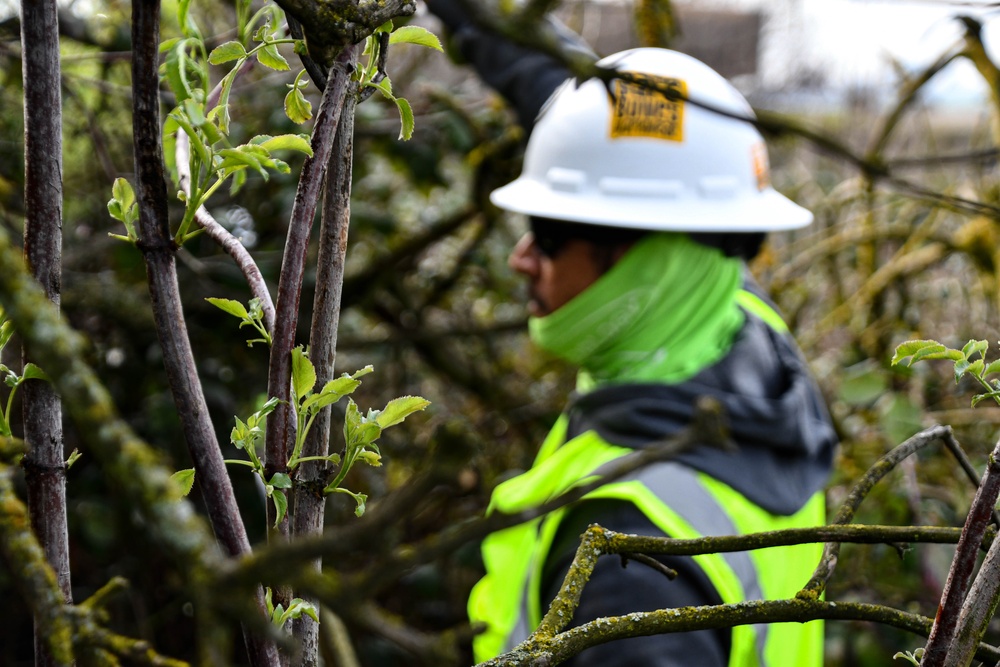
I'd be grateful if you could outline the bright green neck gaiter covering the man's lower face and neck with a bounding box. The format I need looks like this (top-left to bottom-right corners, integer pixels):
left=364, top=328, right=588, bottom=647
left=528, top=233, right=743, bottom=391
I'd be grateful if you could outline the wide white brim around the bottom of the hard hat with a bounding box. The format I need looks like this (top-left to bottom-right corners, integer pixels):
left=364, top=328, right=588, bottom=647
left=490, top=176, right=813, bottom=232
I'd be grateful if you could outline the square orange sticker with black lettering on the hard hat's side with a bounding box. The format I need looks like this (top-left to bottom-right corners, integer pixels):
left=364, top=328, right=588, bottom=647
left=611, top=73, right=687, bottom=141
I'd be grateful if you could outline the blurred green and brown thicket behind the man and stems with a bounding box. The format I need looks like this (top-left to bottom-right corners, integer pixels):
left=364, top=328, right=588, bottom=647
left=0, top=0, right=1000, bottom=666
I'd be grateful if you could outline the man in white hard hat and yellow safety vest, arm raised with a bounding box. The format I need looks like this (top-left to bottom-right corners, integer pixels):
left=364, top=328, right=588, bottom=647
left=430, top=0, right=836, bottom=667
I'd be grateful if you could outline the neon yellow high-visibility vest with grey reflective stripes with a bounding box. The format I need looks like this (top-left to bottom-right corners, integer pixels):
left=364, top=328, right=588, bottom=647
left=469, top=417, right=825, bottom=667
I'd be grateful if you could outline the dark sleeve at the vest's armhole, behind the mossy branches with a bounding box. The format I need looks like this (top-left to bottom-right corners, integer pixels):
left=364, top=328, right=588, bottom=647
left=542, top=501, right=731, bottom=667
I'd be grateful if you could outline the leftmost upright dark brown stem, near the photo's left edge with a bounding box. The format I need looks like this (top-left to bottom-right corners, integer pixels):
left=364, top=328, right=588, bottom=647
left=21, top=0, right=73, bottom=667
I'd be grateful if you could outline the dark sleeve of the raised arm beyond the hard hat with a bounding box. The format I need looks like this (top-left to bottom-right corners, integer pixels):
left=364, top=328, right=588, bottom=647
left=427, top=0, right=579, bottom=133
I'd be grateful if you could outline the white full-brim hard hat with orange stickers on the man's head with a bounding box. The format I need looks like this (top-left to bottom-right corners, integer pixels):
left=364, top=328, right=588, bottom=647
left=490, top=48, right=813, bottom=232
